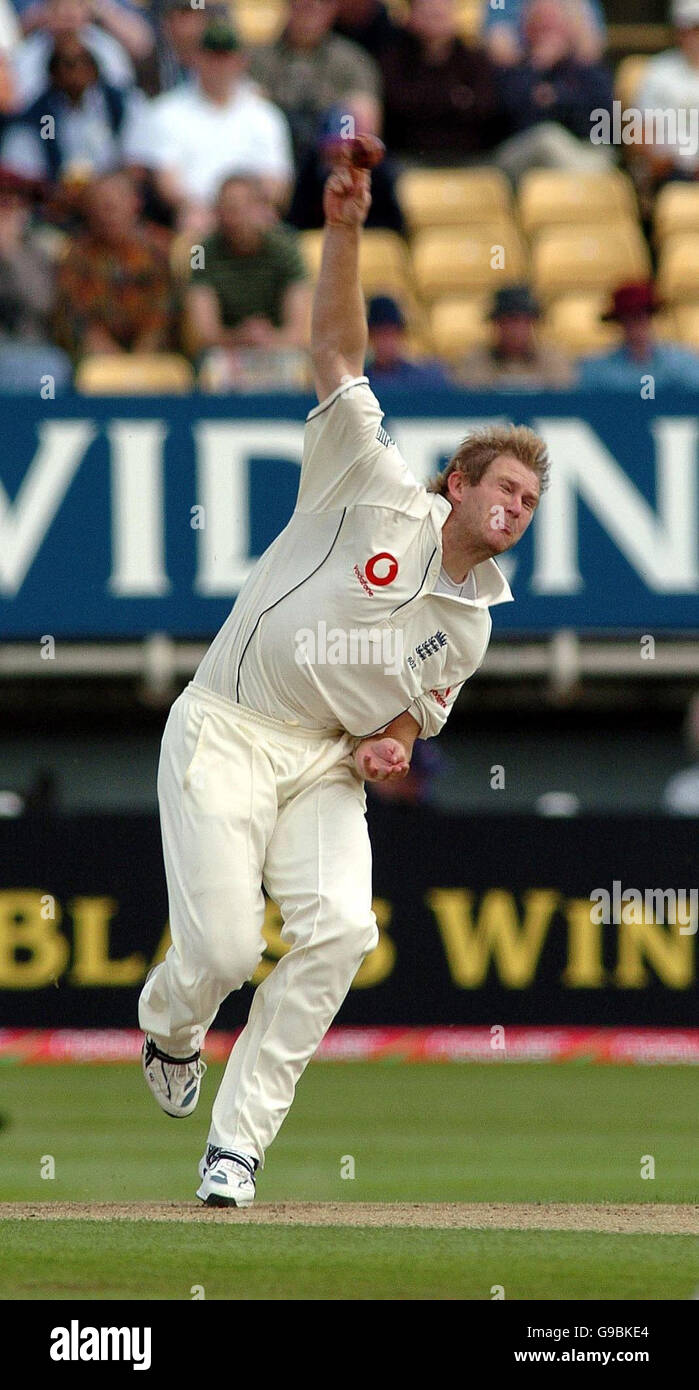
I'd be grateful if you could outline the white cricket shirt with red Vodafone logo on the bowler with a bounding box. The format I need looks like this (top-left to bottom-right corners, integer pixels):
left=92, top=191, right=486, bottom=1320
left=195, top=377, right=513, bottom=738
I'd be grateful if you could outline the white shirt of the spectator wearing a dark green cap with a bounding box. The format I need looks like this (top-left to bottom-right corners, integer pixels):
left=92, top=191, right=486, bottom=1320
left=125, top=82, right=293, bottom=203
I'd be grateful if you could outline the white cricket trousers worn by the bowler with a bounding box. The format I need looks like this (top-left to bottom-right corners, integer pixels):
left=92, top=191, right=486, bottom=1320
left=139, top=684, right=378, bottom=1165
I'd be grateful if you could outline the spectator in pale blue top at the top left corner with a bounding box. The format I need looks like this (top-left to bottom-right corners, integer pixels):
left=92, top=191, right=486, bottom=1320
left=13, top=0, right=135, bottom=110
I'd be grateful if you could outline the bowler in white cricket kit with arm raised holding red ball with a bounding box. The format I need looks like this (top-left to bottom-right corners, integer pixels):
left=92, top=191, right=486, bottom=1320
left=139, top=143, right=548, bottom=1207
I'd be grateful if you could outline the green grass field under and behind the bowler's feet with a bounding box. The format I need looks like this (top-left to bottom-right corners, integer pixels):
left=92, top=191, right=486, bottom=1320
left=0, top=1063, right=699, bottom=1300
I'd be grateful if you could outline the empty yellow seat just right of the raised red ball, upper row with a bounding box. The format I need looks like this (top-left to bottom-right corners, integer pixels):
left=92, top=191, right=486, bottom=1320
left=397, top=168, right=511, bottom=232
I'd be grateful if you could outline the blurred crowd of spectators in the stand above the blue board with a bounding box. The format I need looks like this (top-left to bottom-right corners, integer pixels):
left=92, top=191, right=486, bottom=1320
left=0, top=0, right=699, bottom=392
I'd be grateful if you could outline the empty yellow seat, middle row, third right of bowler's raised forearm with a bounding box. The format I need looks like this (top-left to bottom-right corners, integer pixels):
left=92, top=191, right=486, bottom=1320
left=532, top=221, right=650, bottom=300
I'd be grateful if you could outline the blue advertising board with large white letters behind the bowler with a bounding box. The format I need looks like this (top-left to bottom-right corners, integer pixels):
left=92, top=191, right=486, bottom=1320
left=0, top=391, right=699, bottom=641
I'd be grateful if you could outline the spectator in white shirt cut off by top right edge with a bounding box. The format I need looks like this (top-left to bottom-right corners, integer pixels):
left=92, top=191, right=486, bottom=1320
left=638, top=0, right=699, bottom=193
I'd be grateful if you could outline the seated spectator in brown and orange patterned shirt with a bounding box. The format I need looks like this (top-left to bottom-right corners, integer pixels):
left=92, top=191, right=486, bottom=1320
left=56, top=172, right=172, bottom=360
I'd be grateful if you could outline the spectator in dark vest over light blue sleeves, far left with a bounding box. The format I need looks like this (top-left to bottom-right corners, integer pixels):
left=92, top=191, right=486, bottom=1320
left=1, top=33, right=143, bottom=183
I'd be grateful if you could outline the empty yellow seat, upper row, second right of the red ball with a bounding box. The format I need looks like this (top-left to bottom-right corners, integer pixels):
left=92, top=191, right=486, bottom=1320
left=518, top=170, right=636, bottom=236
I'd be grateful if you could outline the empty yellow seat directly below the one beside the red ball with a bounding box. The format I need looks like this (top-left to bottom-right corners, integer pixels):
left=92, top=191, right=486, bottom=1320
left=413, top=221, right=527, bottom=303
